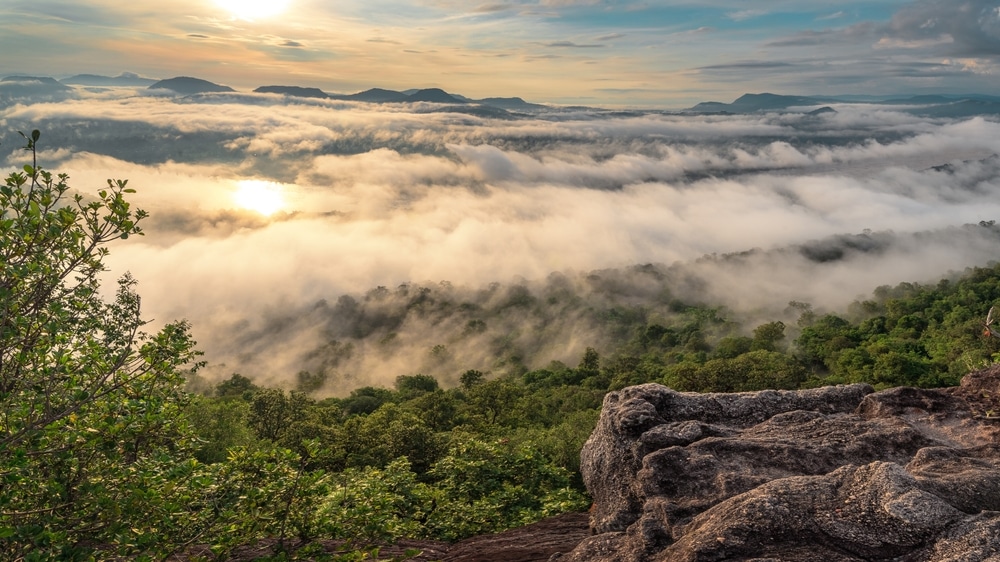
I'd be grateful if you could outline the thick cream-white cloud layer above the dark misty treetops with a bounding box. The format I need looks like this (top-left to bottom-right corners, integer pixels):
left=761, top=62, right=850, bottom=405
left=7, top=91, right=1000, bottom=380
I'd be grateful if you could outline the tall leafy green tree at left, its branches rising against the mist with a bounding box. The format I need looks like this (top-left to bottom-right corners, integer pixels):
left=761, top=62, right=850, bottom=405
left=0, top=131, right=204, bottom=560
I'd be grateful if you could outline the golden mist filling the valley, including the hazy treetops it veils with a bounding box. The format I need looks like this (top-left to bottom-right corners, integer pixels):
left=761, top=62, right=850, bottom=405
left=0, top=81, right=1000, bottom=394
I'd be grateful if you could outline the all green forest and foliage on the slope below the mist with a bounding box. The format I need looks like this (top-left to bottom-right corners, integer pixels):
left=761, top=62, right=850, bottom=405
left=0, top=132, right=1000, bottom=560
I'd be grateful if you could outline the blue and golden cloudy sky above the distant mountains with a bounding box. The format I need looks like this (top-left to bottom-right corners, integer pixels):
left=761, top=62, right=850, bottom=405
left=0, top=0, right=1000, bottom=108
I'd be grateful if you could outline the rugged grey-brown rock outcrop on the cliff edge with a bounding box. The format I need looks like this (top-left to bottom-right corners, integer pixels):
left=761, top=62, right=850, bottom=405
left=555, top=368, right=1000, bottom=562
